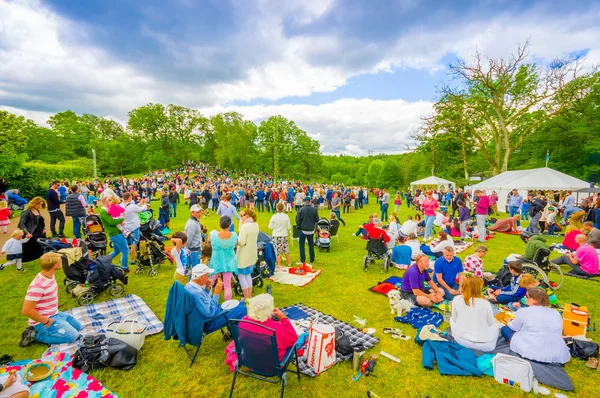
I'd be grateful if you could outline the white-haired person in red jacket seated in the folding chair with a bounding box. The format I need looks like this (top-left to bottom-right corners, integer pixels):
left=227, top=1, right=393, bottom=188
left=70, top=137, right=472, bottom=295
left=240, top=293, right=298, bottom=361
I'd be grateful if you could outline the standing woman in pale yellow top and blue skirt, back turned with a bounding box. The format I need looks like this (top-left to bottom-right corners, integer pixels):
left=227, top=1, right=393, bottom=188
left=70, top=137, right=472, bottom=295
left=236, top=208, right=258, bottom=299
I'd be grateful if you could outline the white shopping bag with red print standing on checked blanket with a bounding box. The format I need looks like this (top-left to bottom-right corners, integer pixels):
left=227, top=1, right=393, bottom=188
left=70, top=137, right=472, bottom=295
left=307, top=323, right=335, bottom=374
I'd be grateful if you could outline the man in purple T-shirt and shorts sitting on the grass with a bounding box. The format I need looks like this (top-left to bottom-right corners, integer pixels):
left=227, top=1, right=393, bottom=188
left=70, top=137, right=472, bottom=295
left=400, top=254, right=444, bottom=307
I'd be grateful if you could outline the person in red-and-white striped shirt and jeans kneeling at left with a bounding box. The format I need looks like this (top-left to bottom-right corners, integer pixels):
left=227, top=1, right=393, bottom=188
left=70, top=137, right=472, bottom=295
left=21, top=252, right=82, bottom=347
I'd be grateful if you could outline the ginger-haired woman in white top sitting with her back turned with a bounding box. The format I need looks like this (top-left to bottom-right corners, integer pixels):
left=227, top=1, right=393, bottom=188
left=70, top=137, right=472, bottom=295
left=450, top=276, right=500, bottom=351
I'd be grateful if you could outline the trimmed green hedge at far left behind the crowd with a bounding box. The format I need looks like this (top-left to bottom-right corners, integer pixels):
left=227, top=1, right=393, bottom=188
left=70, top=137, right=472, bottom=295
left=8, top=162, right=87, bottom=199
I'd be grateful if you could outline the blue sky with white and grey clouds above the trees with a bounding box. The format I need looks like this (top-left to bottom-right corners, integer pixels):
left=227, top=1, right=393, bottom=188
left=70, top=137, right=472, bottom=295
left=0, top=0, right=600, bottom=156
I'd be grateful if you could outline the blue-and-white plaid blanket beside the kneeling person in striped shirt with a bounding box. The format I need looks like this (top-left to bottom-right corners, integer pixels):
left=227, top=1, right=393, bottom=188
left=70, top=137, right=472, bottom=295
left=47, top=294, right=163, bottom=354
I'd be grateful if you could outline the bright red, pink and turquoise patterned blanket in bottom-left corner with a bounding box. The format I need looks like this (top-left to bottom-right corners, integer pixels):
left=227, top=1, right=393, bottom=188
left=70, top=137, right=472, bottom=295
left=0, top=352, right=118, bottom=398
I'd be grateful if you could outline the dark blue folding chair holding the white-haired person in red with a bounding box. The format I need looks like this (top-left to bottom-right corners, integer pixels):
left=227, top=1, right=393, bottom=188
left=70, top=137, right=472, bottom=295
left=229, top=319, right=300, bottom=398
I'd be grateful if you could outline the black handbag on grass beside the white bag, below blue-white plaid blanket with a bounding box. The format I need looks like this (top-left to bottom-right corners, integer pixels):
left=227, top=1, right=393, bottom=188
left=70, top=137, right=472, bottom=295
left=73, top=334, right=137, bottom=373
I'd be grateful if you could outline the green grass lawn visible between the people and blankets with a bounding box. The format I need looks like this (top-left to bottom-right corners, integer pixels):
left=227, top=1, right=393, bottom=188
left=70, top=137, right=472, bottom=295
left=0, top=202, right=600, bottom=398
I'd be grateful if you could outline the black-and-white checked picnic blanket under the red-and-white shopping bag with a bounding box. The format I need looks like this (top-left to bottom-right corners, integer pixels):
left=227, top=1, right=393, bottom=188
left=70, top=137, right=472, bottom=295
left=281, top=304, right=379, bottom=377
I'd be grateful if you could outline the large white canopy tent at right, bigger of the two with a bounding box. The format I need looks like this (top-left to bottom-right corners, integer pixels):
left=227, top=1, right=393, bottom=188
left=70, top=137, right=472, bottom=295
left=470, top=167, right=590, bottom=211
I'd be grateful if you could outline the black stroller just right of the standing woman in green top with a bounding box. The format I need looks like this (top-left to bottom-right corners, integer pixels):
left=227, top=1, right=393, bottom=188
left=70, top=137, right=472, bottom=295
left=135, top=212, right=173, bottom=276
